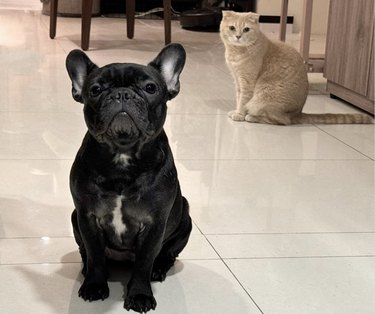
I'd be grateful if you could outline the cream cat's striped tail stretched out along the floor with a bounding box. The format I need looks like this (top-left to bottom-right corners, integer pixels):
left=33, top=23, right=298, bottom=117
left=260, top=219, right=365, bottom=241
left=292, top=113, right=374, bottom=124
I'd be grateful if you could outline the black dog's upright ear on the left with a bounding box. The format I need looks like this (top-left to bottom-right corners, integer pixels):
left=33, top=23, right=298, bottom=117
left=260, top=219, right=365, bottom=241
left=66, top=49, right=97, bottom=103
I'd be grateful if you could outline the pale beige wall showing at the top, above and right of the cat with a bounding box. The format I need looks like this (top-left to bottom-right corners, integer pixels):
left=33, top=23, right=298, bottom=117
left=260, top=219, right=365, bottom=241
left=257, top=0, right=329, bottom=34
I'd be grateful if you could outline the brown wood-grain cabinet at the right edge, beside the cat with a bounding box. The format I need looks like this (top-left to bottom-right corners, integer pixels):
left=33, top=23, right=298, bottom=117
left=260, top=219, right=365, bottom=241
left=324, top=0, right=374, bottom=114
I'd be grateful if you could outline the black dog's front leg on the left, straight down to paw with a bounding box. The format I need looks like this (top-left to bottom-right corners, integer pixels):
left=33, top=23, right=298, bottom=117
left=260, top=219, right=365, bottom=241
left=78, top=211, right=109, bottom=302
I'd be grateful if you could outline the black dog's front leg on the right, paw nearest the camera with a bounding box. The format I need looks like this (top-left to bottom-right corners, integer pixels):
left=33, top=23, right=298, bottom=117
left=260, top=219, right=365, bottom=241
left=124, top=223, right=165, bottom=313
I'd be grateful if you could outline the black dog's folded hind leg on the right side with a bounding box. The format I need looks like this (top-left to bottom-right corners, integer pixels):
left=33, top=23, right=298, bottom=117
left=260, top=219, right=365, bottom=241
left=151, top=198, right=192, bottom=281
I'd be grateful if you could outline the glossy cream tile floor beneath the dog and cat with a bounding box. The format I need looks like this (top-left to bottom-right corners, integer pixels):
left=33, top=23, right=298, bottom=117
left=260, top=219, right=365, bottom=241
left=0, top=10, right=375, bottom=314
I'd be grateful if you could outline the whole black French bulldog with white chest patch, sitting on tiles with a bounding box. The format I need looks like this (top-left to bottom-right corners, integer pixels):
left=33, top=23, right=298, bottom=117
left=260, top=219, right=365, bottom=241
left=66, top=44, right=192, bottom=313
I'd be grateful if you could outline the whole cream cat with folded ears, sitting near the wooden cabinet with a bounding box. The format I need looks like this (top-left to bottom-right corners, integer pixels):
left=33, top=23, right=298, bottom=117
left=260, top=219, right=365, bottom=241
left=220, top=11, right=373, bottom=125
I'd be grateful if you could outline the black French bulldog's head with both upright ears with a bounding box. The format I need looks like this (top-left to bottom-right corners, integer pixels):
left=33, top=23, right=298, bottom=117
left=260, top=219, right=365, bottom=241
left=66, top=44, right=186, bottom=150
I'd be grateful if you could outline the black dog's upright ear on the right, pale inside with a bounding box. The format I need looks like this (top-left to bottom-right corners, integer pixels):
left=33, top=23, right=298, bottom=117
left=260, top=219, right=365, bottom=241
left=149, top=44, right=186, bottom=99
